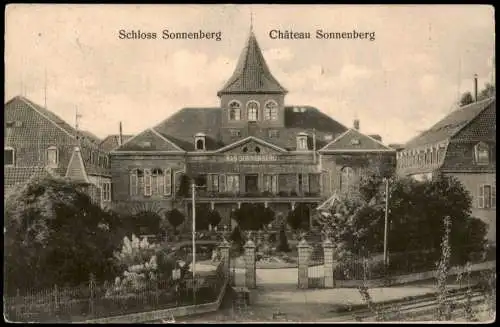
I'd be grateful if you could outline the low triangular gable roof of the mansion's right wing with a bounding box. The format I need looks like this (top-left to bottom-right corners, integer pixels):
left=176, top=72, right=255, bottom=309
left=319, top=128, right=395, bottom=152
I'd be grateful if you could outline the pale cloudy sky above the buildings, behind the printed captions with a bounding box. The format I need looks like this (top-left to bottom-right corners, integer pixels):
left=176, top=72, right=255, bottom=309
left=5, top=4, right=495, bottom=144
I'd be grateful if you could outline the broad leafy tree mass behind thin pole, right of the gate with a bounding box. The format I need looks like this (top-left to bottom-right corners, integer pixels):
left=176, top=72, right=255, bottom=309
left=316, top=176, right=486, bottom=265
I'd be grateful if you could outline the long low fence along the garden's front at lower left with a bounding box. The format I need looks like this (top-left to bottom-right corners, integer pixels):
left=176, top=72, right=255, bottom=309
left=5, top=251, right=228, bottom=322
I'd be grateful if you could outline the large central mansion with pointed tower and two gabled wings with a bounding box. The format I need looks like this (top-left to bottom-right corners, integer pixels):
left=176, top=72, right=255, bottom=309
left=110, top=32, right=395, bottom=228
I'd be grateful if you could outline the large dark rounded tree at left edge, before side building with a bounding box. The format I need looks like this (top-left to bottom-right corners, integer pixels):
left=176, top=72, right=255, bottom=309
left=4, top=176, right=124, bottom=291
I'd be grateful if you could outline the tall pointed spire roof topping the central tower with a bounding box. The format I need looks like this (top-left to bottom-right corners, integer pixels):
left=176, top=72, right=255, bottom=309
left=217, top=31, right=287, bottom=96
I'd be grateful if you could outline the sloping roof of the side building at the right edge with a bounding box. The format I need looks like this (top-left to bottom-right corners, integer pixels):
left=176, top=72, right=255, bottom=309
left=404, top=97, right=495, bottom=149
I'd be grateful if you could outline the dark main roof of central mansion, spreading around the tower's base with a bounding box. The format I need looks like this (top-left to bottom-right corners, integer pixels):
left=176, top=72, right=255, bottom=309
left=145, top=106, right=347, bottom=151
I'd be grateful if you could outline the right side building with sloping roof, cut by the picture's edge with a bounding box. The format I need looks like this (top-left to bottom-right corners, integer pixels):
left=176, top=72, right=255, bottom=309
left=397, top=97, right=496, bottom=242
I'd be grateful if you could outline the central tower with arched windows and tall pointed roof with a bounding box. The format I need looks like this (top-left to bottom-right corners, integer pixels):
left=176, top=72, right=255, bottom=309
left=217, top=30, right=287, bottom=128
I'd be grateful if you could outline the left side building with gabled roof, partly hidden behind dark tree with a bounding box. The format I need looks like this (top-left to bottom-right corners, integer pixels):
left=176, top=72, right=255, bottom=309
left=4, top=96, right=111, bottom=206
